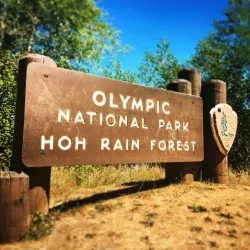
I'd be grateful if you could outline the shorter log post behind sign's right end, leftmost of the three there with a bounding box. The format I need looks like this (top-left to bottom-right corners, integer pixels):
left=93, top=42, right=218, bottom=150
left=165, top=79, right=194, bottom=184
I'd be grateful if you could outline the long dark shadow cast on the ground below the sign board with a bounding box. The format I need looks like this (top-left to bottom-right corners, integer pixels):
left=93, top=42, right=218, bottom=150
left=50, top=179, right=169, bottom=212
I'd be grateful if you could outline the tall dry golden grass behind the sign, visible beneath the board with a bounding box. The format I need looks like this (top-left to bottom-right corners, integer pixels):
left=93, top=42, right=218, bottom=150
left=51, top=164, right=250, bottom=190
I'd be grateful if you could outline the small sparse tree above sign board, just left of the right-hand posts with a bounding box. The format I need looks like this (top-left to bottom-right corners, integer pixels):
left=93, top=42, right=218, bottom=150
left=139, top=39, right=180, bottom=88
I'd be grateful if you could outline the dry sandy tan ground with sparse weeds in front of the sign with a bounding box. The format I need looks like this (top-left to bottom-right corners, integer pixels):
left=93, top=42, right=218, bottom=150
left=0, top=181, right=250, bottom=250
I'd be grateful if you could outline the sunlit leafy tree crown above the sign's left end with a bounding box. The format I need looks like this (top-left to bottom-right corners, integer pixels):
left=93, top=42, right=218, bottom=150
left=0, top=0, right=119, bottom=71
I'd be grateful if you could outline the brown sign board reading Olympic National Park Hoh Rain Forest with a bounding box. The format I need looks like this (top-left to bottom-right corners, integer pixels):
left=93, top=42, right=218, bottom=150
left=22, top=63, right=204, bottom=167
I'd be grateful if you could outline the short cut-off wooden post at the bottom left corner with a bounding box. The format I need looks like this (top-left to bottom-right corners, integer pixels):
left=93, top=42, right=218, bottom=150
left=0, top=171, right=29, bottom=243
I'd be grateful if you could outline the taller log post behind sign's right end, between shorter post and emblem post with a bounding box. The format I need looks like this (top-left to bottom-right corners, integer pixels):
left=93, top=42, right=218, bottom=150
left=178, top=68, right=202, bottom=181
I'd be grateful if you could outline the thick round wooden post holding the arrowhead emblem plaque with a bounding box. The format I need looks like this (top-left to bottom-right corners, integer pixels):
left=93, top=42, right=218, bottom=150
left=201, top=80, right=228, bottom=184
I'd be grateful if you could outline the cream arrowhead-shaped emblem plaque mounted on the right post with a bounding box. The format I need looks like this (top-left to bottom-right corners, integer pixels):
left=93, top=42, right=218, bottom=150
left=210, top=104, right=238, bottom=155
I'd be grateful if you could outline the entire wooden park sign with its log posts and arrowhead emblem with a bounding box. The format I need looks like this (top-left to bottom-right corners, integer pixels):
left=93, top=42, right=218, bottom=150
left=0, top=54, right=237, bottom=243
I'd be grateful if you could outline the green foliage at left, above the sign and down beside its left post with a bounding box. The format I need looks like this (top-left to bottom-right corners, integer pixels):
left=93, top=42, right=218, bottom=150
left=0, top=0, right=123, bottom=166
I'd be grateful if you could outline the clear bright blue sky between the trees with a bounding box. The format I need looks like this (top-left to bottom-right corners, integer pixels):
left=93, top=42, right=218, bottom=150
left=98, top=0, right=228, bottom=71
